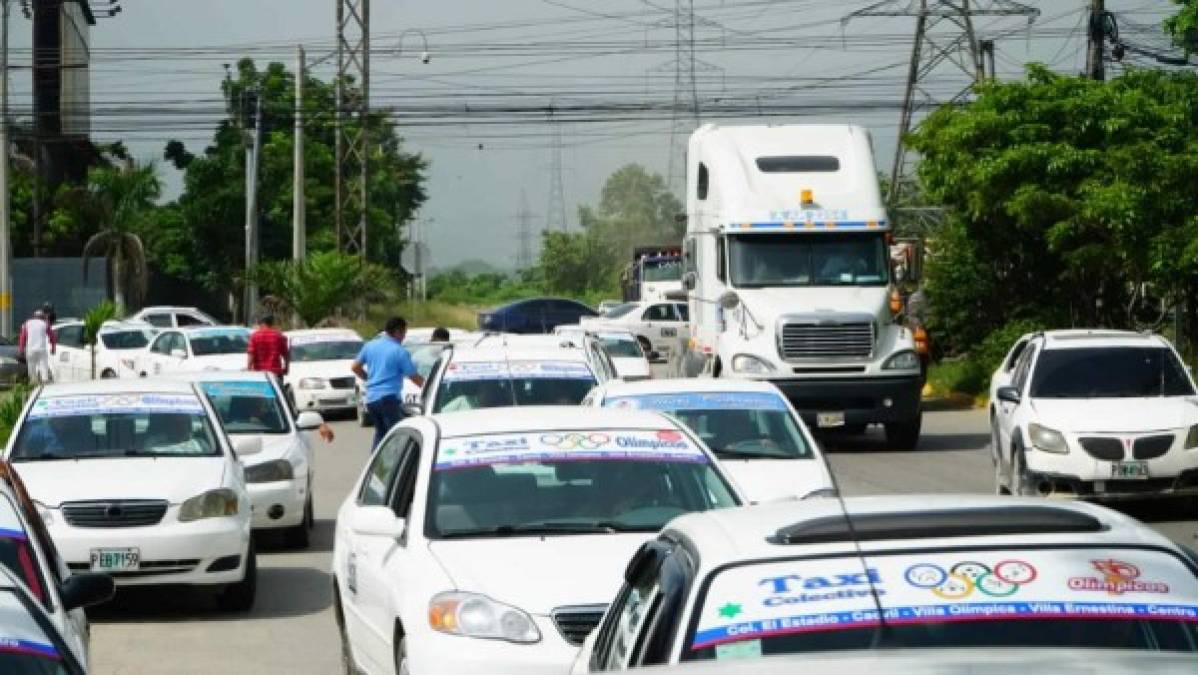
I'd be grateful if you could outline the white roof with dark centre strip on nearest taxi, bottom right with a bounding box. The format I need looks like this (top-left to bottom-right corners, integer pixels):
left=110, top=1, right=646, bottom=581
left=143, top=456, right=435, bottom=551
left=666, top=494, right=1176, bottom=568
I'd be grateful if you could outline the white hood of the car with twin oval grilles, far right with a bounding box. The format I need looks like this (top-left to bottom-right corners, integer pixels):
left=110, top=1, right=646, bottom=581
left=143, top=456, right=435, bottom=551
left=1031, top=396, right=1198, bottom=433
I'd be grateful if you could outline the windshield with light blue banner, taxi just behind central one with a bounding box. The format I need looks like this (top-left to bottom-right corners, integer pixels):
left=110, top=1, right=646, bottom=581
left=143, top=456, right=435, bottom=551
left=604, top=392, right=815, bottom=459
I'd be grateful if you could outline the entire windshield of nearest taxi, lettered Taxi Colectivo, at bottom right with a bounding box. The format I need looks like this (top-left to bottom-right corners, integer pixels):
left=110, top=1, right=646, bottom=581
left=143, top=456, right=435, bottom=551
left=682, top=546, right=1198, bottom=661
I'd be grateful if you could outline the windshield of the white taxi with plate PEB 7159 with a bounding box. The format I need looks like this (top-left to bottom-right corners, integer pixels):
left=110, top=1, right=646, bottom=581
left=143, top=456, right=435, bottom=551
left=12, top=393, right=220, bottom=462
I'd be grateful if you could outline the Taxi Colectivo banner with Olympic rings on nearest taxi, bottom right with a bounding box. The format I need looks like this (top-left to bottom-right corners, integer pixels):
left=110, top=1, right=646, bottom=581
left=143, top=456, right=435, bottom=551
left=689, top=548, right=1198, bottom=650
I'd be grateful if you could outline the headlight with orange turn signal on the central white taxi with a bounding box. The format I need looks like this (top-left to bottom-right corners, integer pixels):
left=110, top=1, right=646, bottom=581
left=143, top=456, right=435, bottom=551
left=429, top=591, right=540, bottom=644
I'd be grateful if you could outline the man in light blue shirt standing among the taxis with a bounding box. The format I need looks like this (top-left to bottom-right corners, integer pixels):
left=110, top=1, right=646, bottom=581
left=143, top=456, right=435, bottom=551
left=350, top=317, right=424, bottom=450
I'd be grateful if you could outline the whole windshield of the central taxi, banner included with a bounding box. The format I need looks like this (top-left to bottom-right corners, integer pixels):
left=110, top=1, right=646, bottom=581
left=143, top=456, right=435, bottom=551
left=426, top=429, right=737, bottom=537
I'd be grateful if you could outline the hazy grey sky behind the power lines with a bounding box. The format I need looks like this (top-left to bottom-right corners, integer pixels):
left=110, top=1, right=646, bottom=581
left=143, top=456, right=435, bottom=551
left=12, top=0, right=1170, bottom=265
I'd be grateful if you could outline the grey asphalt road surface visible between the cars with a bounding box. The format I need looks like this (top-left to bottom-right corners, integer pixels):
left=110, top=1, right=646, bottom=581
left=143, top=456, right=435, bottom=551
left=91, top=410, right=1198, bottom=675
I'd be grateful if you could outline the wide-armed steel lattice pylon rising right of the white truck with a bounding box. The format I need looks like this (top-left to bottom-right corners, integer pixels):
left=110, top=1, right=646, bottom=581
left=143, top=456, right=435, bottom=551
left=842, top=0, right=1040, bottom=232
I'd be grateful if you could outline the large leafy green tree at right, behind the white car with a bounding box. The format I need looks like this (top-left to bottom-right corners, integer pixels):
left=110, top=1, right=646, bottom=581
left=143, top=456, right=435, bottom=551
left=910, top=66, right=1198, bottom=357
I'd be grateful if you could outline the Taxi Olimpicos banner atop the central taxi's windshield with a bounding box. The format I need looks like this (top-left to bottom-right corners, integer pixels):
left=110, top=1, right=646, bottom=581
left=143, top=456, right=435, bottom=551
left=434, top=429, right=707, bottom=471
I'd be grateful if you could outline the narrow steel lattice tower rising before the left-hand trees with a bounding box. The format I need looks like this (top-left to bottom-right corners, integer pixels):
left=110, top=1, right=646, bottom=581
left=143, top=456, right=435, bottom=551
left=334, top=0, right=370, bottom=258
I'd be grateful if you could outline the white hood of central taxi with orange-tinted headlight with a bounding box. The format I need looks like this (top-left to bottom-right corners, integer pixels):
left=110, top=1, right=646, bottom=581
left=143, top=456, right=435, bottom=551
left=429, top=532, right=654, bottom=616
